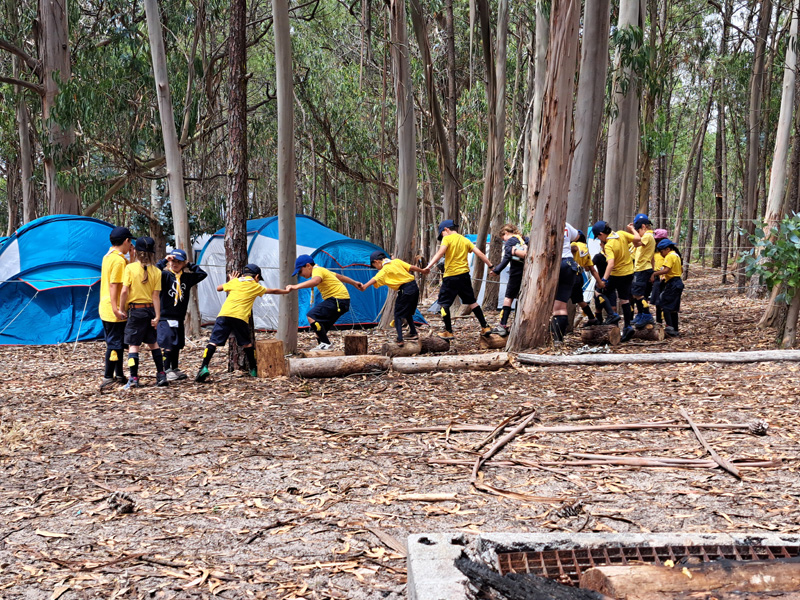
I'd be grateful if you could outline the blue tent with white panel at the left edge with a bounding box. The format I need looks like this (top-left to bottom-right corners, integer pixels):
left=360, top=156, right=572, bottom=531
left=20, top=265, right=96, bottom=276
left=0, top=215, right=113, bottom=344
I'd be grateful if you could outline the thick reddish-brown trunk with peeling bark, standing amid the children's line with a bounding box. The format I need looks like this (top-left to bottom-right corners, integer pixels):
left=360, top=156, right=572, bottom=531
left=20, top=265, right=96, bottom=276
left=508, top=0, right=581, bottom=351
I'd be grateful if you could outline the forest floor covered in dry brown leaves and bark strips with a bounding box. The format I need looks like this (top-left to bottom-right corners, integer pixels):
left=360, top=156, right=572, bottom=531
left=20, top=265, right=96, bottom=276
left=0, top=267, right=800, bottom=600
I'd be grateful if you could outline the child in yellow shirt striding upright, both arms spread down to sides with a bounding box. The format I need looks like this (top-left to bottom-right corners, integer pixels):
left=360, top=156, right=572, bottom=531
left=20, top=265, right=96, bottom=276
left=423, top=219, right=493, bottom=339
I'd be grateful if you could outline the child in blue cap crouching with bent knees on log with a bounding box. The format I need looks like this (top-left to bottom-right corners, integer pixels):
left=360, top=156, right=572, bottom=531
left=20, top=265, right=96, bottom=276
left=285, top=254, right=359, bottom=350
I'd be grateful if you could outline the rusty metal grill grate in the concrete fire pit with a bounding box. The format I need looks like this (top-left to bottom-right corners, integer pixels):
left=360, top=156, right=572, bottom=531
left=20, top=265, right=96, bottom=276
left=497, top=545, right=800, bottom=587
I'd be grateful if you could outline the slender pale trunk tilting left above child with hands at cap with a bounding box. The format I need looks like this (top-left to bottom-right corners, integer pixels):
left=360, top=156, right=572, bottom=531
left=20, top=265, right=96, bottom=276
left=144, top=0, right=192, bottom=251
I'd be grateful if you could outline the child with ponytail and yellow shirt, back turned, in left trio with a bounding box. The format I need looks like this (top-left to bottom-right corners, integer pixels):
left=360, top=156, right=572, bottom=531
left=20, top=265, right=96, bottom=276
left=119, top=237, right=169, bottom=390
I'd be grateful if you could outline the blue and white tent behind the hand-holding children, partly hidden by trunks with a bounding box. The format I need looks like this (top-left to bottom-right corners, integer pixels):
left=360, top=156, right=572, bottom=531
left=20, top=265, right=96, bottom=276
left=197, top=215, right=424, bottom=331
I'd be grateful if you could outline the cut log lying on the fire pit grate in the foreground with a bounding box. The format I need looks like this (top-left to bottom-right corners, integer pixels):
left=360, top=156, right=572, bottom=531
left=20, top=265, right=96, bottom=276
left=580, top=558, right=800, bottom=600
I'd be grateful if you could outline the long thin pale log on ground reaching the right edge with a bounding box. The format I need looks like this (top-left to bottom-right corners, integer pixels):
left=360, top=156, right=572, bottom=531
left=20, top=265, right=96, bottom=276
left=517, top=350, right=800, bottom=366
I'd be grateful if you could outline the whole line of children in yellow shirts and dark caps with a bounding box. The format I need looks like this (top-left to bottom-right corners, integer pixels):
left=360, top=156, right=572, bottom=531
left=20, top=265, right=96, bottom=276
left=99, top=214, right=683, bottom=389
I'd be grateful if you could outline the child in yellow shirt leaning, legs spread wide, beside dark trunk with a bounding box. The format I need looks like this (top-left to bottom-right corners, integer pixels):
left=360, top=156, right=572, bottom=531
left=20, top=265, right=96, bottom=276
left=194, top=264, right=287, bottom=383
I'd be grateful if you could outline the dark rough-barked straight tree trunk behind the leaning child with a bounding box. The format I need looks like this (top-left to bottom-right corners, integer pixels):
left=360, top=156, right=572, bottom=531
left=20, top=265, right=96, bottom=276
left=224, top=0, right=253, bottom=371
